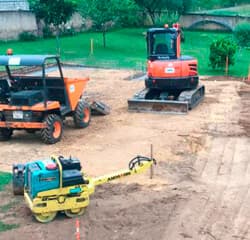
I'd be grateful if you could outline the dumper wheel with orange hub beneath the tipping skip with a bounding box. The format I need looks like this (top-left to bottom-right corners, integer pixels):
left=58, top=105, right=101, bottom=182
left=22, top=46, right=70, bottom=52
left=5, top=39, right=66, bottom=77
left=73, top=100, right=91, bottom=128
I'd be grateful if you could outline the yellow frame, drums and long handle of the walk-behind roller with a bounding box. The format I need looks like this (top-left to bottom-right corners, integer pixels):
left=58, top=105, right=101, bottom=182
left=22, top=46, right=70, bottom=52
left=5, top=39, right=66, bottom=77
left=24, top=156, right=155, bottom=223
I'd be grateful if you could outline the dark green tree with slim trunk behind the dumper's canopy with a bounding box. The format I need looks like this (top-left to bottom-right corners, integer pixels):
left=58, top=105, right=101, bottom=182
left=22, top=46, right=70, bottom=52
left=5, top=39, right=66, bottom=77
left=30, top=0, right=77, bottom=55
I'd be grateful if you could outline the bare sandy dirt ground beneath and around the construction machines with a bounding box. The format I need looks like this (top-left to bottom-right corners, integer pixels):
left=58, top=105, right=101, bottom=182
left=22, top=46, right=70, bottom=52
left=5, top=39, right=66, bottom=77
left=0, top=69, right=250, bottom=240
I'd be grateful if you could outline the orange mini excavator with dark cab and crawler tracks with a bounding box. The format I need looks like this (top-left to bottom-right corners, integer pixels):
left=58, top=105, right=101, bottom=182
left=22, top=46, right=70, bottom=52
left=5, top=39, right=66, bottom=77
left=128, top=23, right=205, bottom=113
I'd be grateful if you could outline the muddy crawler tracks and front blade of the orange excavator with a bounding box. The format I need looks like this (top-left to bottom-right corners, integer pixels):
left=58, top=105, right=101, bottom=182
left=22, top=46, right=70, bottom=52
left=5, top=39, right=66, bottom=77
left=128, top=85, right=205, bottom=114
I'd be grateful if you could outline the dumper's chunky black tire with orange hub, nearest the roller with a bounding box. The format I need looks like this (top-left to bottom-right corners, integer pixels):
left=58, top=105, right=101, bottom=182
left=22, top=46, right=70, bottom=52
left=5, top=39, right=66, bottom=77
left=41, top=114, right=63, bottom=144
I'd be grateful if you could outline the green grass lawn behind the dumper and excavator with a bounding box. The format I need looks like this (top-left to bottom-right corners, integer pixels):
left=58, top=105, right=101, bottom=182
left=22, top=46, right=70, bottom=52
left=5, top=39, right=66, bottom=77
left=0, top=29, right=250, bottom=77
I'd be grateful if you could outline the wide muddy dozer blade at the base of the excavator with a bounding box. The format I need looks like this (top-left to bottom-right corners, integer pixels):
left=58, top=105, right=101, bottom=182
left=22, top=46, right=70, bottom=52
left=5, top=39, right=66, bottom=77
left=128, top=98, right=188, bottom=114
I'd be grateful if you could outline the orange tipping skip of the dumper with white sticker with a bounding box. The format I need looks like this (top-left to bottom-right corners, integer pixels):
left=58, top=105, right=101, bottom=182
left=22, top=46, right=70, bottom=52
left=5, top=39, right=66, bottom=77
left=64, top=77, right=89, bottom=110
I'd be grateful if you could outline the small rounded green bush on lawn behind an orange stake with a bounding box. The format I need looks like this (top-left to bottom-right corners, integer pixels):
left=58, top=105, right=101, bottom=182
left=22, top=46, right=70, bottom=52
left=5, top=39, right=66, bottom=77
left=209, top=38, right=237, bottom=69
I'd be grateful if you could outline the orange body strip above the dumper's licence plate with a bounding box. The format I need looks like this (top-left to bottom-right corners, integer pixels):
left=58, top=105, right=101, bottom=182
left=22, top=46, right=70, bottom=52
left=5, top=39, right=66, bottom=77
left=0, top=101, right=60, bottom=112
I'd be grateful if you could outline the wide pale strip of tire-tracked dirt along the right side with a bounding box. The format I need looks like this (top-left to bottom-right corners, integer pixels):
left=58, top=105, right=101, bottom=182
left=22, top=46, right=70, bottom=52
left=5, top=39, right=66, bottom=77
left=160, top=81, right=250, bottom=240
